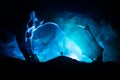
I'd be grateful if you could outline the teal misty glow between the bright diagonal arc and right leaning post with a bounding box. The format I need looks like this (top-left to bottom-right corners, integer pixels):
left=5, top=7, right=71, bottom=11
left=54, top=13, right=102, bottom=61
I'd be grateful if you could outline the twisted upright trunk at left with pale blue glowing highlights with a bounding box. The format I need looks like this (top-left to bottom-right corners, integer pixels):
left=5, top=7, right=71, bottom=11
left=25, top=11, right=39, bottom=62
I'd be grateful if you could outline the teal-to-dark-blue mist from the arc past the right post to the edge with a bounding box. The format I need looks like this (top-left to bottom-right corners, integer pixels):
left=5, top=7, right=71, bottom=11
left=53, top=12, right=120, bottom=63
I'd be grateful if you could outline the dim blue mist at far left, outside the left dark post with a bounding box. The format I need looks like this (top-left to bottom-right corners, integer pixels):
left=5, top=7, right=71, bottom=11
left=0, top=31, right=25, bottom=60
